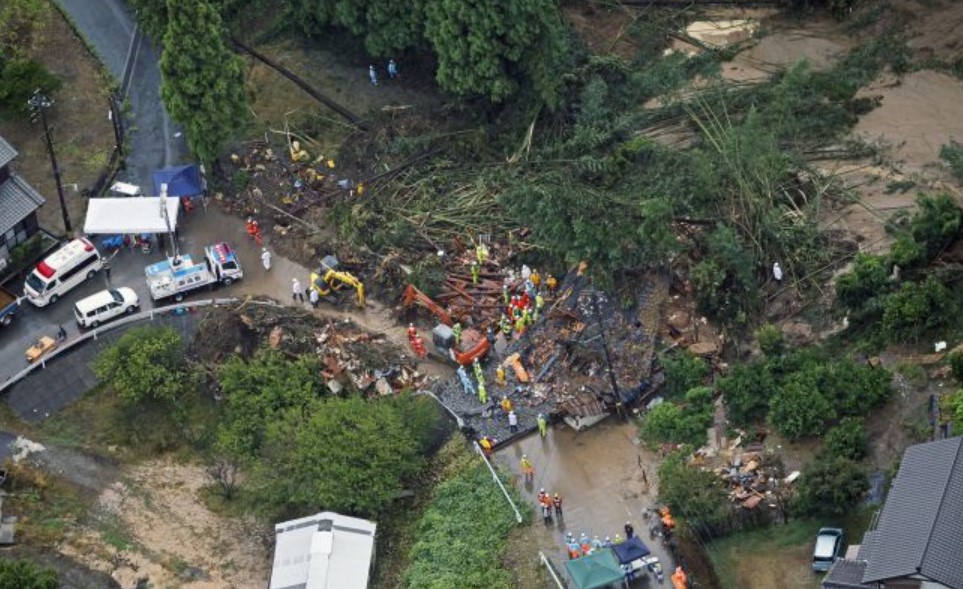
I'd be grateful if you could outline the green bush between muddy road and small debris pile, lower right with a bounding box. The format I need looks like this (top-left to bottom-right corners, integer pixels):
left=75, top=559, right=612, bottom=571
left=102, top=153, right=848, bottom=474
left=659, top=452, right=729, bottom=532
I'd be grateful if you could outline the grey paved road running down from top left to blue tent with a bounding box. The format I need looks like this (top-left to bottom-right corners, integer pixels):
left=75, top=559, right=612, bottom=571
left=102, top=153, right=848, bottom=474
left=57, top=0, right=189, bottom=192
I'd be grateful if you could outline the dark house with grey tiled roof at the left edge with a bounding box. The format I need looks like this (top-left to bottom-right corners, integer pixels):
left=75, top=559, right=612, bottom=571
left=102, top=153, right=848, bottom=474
left=0, top=137, right=46, bottom=267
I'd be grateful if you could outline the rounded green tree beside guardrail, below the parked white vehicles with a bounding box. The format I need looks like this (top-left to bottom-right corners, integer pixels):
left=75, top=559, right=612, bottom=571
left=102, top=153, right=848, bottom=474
left=92, top=327, right=188, bottom=404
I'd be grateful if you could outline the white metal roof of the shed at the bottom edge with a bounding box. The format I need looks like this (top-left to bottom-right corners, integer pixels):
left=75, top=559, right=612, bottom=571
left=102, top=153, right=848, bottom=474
left=270, top=511, right=377, bottom=589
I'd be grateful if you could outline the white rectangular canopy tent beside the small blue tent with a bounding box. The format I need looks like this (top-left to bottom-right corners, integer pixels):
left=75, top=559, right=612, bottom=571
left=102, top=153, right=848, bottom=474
left=84, top=196, right=180, bottom=235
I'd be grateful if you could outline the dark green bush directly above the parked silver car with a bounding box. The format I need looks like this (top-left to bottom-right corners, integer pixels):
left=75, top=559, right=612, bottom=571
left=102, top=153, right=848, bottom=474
left=792, top=456, right=869, bottom=515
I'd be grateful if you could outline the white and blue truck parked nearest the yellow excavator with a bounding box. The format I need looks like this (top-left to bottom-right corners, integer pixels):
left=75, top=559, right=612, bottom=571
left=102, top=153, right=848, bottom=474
left=144, top=243, right=244, bottom=302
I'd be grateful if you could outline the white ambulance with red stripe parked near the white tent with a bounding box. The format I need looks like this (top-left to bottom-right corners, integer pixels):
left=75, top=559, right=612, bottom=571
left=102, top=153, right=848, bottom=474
left=23, top=239, right=104, bottom=307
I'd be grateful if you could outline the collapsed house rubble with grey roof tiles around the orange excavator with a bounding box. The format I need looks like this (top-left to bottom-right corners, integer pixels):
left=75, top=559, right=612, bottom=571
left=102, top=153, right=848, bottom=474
left=435, top=266, right=667, bottom=442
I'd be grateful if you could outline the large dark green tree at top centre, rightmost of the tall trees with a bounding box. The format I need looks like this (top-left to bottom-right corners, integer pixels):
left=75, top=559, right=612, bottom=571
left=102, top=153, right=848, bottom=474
left=425, top=0, right=562, bottom=106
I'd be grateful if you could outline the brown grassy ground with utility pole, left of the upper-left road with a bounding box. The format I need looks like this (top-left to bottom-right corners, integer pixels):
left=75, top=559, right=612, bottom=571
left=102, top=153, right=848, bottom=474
left=0, top=8, right=114, bottom=232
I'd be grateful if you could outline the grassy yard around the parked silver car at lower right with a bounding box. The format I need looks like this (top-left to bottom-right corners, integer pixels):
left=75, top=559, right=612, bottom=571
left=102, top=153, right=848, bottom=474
left=708, top=508, right=873, bottom=589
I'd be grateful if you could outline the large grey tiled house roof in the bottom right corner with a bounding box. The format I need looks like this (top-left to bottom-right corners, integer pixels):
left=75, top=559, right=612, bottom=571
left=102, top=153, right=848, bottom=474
left=863, top=437, right=963, bottom=589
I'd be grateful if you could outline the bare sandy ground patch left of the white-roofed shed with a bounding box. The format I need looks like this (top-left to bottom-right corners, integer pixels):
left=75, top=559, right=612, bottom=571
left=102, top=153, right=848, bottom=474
left=61, top=459, right=272, bottom=589
